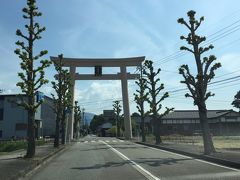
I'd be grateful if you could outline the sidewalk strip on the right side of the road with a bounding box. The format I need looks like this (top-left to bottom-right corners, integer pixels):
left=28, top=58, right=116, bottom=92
left=134, top=141, right=240, bottom=169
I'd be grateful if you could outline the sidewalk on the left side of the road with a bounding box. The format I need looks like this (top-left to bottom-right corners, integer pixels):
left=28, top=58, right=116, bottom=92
left=0, top=143, right=66, bottom=180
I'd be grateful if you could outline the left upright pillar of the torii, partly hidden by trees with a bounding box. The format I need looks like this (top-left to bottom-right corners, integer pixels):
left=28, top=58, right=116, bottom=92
left=67, top=66, right=76, bottom=140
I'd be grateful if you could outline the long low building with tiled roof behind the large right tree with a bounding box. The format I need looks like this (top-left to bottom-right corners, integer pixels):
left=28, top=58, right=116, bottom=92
left=161, top=110, right=240, bottom=135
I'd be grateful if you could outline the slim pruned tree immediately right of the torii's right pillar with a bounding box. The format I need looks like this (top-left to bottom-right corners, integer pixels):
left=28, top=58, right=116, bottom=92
left=134, top=66, right=149, bottom=142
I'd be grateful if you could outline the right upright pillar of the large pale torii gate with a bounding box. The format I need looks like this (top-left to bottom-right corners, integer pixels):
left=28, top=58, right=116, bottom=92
left=120, top=66, right=132, bottom=139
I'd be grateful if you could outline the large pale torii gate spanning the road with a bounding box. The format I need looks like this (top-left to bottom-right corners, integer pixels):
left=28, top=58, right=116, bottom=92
left=50, top=56, right=145, bottom=139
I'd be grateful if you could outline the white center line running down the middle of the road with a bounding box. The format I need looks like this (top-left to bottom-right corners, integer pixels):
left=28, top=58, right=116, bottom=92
left=102, top=141, right=160, bottom=180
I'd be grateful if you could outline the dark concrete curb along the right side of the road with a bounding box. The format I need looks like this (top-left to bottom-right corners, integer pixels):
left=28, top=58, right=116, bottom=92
left=135, top=142, right=240, bottom=169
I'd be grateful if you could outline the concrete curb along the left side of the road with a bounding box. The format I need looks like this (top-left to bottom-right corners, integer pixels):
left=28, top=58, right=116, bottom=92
left=16, top=143, right=75, bottom=180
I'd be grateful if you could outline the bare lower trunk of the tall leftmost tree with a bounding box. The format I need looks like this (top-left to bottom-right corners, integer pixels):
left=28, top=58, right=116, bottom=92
left=25, top=110, right=36, bottom=158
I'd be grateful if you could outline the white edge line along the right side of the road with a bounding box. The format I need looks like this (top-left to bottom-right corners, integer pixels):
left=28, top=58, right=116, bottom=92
left=137, top=144, right=240, bottom=172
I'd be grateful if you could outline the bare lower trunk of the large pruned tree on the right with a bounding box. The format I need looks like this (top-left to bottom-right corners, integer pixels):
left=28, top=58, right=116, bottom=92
left=198, top=105, right=216, bottom=154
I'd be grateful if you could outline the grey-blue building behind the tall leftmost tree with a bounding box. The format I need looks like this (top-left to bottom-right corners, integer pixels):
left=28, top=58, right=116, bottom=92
left=0, top=94, right=55, bottom=139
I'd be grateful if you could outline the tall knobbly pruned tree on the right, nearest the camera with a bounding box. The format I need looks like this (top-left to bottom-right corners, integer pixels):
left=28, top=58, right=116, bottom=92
left=178, top=11, right=221, bottom=154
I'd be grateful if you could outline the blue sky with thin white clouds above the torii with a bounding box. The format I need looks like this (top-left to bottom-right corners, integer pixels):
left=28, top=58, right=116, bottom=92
left=0, top=0, right=240, bottom=113
